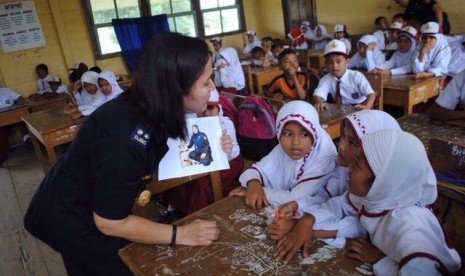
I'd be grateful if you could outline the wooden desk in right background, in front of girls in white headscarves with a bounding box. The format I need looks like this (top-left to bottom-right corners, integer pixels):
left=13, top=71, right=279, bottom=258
left=383, top=75, right=442, bottom=115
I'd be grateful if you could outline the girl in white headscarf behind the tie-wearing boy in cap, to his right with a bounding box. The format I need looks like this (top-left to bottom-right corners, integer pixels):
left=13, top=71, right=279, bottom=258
left=347, top=35, right=385, bottom=72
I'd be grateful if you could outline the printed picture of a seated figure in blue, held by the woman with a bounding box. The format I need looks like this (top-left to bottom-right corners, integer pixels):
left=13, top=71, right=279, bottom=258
left=158, top=117, right=229, bottom=180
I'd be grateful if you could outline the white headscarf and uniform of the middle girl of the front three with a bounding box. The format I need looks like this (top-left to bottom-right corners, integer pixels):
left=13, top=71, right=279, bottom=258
left=299, top=109, right=401, bottom=247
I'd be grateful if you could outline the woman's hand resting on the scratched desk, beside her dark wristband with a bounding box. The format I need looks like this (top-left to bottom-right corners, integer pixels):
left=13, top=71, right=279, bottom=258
left=176, top=219, right=220, bottom=245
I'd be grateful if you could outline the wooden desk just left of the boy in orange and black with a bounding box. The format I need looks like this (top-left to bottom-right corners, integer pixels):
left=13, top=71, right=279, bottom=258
left=242, top=65, right=283, bottom=95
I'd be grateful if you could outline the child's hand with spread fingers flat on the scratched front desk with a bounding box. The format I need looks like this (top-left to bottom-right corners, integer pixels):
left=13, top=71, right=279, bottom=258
left=274, top=214, right=315, bottom=264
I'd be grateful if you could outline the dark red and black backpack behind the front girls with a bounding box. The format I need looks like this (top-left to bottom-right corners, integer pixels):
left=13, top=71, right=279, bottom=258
left=236, top=96, right=278, bottom=161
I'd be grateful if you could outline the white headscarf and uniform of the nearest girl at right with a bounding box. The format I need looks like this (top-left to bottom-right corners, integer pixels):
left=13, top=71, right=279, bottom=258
left=356, top=130, right=461, bottom=275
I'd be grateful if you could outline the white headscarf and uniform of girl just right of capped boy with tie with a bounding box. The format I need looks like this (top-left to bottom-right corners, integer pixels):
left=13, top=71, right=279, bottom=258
left=347, top=35, right=385, bottom=72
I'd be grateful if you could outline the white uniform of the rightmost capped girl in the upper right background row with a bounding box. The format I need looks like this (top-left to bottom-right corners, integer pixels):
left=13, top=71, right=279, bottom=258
left=412, top=34, right=451, bottom=77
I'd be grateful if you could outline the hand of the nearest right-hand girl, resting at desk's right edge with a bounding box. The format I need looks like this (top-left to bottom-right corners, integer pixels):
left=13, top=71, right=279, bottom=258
left=345, top=237, right=386, bottom=264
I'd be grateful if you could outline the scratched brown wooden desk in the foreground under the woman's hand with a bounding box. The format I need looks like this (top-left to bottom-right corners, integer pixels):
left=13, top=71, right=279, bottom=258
left=119, top=196, right=371, bottom=275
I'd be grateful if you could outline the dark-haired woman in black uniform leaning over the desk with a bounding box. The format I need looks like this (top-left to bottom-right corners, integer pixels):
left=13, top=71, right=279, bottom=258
left=24, top=33, right=221, bottom=275
